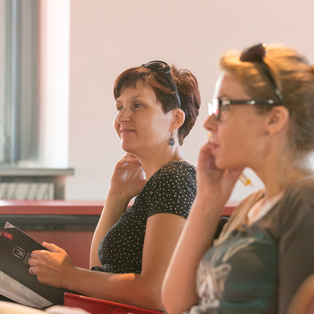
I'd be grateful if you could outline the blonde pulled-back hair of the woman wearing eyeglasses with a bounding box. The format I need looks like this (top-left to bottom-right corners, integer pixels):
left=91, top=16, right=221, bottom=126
left=220, top=44, right=314, bottom=153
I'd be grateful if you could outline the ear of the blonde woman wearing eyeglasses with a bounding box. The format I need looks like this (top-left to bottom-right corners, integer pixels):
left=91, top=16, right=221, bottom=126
left=266, top=106, right=289, bottom=135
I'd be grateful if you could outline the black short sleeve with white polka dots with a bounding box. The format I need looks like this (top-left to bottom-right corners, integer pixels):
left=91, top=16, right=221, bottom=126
left=147, top=162, right=196, bottom=218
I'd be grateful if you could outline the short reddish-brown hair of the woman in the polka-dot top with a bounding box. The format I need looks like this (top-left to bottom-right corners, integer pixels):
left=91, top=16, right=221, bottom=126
left=113, top=66, right=201, bottom=145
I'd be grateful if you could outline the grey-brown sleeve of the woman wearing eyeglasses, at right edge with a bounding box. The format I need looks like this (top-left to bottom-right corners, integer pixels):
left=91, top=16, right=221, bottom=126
left=278, top=180, right=314, bottom=313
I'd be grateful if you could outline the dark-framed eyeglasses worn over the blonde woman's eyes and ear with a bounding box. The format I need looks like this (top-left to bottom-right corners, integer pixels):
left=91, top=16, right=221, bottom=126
left=208, top=98, right=280, bottom=121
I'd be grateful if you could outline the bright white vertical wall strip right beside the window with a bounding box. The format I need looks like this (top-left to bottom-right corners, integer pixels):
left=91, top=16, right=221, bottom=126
left=39, top=0, right=70, bottom=168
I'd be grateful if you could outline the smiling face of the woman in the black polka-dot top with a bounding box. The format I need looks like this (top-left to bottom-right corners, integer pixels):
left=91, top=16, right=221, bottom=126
left=114, top=81, right=172, bottom=157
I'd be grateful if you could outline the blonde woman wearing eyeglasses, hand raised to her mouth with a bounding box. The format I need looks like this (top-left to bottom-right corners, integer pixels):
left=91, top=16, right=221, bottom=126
left=162, top=44, right=314, bottom=314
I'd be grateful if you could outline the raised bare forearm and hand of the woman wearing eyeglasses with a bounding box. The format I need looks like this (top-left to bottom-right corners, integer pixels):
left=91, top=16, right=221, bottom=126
left=162, top=145, right=241, bottom=314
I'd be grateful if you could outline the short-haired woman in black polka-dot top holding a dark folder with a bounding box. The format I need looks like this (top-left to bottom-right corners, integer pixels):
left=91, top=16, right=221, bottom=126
left=29, top=61, right=200, bottom=310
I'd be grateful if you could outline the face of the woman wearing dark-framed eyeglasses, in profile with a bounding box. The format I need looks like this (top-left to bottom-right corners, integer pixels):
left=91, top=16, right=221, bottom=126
left=204, top=72, right=266, bottom=169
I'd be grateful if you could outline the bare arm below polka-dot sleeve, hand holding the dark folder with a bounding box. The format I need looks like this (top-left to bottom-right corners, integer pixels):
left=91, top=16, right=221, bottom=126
left=29, top=213, right=185, bottom=310
